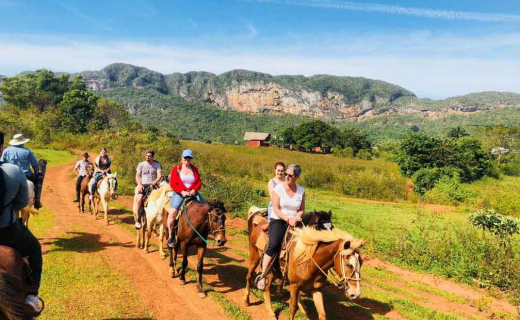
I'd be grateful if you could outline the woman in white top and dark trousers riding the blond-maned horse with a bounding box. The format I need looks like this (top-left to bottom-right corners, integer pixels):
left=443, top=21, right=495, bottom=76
left=257, top=164, right=305, bottom=290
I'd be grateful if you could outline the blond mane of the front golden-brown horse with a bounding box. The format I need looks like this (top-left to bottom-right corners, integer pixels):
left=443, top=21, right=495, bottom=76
left=293, top=227, right=354, bottom=264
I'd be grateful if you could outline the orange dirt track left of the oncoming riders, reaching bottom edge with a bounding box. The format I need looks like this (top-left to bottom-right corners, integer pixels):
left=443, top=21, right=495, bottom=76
left=40, top=162, right=227, bottom=320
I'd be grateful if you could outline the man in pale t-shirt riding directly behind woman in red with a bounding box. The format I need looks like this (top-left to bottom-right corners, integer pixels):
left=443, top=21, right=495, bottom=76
left=134, top=150, right=162, bottom=229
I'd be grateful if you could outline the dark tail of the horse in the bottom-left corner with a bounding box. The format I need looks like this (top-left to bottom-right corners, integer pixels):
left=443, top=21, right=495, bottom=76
left=0, top=272, right=25, bottom=320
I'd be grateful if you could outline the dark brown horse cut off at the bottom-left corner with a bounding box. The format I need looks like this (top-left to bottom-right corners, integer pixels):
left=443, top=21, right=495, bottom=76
left=0, top=246, right=43, bottom=320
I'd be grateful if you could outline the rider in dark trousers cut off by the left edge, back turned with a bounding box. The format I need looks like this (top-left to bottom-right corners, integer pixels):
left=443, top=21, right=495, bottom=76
left=0, top=132, right=43, bottom=312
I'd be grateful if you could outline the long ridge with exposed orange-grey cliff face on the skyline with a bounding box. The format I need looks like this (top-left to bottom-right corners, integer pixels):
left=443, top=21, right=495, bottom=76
left=80, top=63, right=415, bottom=119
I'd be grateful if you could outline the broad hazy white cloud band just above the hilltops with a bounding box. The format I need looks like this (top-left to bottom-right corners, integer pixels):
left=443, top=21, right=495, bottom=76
left=0, top=32, right=520, bottom=98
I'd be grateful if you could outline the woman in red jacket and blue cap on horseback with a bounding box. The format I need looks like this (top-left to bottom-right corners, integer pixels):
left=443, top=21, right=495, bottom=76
left=168, top=149, right=206, bottom=248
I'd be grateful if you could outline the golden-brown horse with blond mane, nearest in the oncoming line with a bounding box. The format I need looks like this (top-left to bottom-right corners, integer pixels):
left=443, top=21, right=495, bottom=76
left=244, top=208, right=365, bottom=320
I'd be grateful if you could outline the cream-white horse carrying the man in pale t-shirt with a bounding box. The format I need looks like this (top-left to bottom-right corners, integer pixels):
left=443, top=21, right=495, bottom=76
left=134, top=182, right=172, bottom=259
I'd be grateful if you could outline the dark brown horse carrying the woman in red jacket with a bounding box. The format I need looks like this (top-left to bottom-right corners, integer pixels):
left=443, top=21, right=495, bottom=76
left=168, top=201, right=227, bottom=298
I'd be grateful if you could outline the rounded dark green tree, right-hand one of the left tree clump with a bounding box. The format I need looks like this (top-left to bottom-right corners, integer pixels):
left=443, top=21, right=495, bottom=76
left=59, top=89, right=99, bottom=133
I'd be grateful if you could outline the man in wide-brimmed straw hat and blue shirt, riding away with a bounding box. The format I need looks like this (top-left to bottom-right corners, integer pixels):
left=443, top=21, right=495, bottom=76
left=1, top=133, right=42, bottom=209
